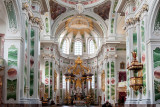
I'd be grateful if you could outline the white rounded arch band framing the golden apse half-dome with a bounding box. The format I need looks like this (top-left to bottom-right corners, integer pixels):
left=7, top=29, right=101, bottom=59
left=51, top=10, right=108, bottom=39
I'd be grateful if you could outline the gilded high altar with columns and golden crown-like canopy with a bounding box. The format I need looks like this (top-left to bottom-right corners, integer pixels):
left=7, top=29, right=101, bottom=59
left=65, top=57, right=93, bottom=104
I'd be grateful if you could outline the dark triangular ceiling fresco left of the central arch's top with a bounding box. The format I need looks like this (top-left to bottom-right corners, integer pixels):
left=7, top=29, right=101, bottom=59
left=49, top=0, right=66, bottom=20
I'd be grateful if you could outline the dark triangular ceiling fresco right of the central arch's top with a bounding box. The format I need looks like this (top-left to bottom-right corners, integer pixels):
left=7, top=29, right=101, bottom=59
left=94, top=1, right=111, bottom=20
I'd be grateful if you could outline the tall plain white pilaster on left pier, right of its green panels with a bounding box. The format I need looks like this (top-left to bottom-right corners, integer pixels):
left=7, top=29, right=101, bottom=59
left=31, top=0, right=41, bottom=104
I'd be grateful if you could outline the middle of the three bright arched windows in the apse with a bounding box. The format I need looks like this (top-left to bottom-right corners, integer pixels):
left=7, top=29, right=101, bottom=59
left=74, top=41, right=82, bottom=55
